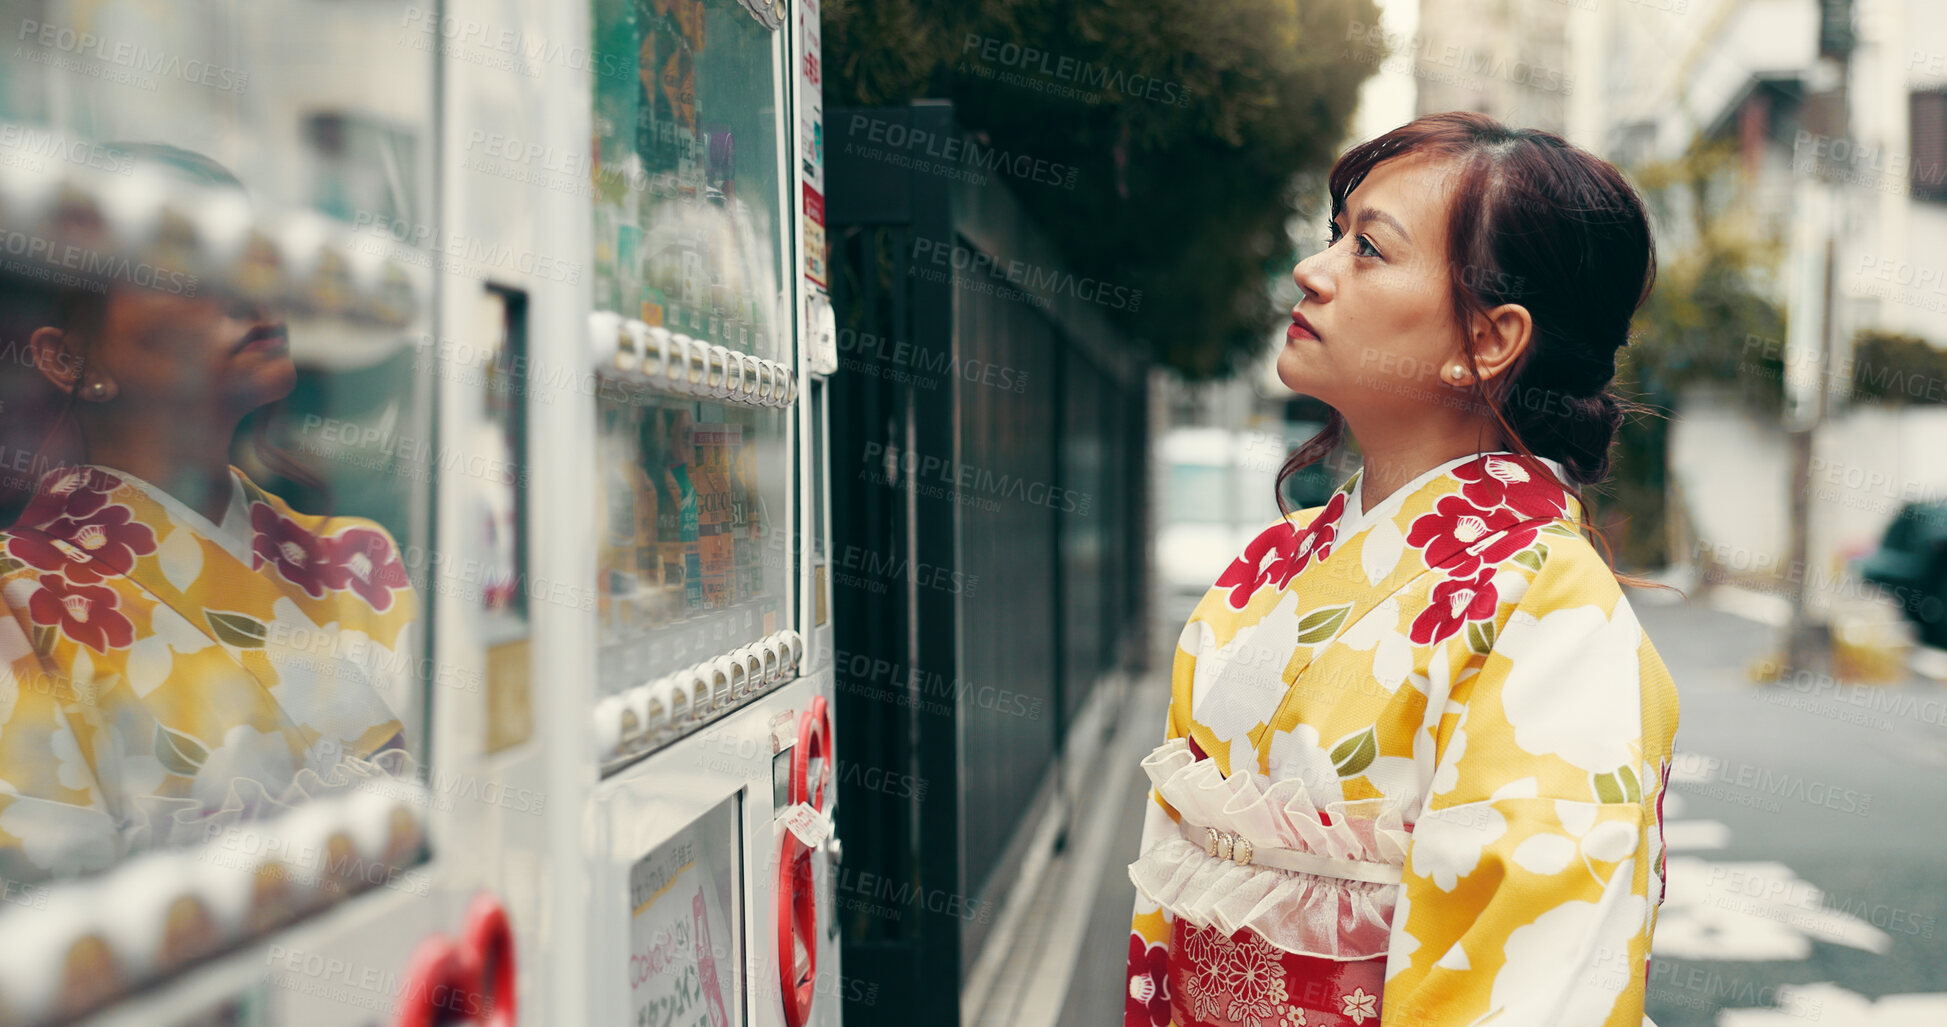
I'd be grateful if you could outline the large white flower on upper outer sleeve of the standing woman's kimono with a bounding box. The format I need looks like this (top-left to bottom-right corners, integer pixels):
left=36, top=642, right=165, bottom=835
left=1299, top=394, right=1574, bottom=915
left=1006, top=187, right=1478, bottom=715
left=1493, top=602, right=1643, bottom=774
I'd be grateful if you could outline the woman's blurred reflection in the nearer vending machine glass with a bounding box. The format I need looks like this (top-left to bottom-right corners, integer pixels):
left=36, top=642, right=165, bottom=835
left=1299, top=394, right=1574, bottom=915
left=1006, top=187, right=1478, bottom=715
left=0, top=148, right=417, bottom=879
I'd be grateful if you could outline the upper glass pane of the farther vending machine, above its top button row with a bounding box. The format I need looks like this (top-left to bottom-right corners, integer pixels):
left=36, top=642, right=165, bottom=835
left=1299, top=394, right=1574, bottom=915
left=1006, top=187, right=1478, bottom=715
left=594, top=0, right=790, bottom=361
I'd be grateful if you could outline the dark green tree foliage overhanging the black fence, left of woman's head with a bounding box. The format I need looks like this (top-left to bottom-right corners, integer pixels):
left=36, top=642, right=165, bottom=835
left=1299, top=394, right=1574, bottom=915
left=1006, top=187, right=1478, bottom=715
left=824, top=0, right=1378, bottom=380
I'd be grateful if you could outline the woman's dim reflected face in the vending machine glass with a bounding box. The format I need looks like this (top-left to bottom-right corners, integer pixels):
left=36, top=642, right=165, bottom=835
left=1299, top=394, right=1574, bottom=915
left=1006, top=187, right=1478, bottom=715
left=82, top=288, right=298, bottom=417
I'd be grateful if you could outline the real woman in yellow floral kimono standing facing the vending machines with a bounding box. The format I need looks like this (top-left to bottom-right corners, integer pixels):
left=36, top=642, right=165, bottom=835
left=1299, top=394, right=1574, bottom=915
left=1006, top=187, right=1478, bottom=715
left=1125, top=113, right=1676, bottom=1027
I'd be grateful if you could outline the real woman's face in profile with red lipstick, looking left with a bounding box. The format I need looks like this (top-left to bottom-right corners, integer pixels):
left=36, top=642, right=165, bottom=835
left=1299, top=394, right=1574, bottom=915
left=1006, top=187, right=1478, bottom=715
left=1277, top=156, right=1460, bottom=417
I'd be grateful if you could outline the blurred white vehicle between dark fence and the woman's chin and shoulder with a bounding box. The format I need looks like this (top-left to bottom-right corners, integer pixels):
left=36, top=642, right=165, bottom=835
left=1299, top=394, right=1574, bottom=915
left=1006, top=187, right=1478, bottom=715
left=1157, top=421, right=1338, bottom=594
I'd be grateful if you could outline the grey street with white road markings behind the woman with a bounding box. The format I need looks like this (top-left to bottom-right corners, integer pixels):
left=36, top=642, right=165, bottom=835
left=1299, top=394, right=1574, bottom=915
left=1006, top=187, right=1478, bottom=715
left=1055, top=592, right=1947, bottom=1027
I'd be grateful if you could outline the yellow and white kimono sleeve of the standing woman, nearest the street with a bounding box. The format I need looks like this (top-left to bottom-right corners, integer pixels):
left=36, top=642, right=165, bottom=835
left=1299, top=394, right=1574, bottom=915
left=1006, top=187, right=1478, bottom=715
left=1382, top=538, right=1674, bottom=1027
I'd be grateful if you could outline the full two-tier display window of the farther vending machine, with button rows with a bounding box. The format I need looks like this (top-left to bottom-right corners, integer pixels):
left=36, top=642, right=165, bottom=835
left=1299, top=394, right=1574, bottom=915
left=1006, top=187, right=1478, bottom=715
left=590, top=0, right=798, bottom=770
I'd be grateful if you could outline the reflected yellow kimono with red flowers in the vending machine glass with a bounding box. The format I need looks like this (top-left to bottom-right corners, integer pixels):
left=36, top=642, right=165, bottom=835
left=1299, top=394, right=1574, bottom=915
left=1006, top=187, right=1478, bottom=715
left=0, top=466, right=417, bottom=881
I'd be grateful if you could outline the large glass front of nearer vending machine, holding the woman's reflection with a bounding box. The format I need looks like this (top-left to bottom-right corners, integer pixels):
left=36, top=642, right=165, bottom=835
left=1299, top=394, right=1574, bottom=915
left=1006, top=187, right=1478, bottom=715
left=0, top=0, right=442, bottom=1021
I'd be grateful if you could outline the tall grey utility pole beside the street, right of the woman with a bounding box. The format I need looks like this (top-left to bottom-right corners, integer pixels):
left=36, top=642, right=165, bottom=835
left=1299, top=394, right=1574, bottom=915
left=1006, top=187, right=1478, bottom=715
left=1780, top=0, right=1854, bottom=674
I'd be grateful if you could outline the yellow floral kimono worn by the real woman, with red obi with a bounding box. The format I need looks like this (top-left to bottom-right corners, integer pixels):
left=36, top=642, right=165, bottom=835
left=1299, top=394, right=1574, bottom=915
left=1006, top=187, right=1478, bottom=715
left=1123, top=452, right=1676, bottom=1027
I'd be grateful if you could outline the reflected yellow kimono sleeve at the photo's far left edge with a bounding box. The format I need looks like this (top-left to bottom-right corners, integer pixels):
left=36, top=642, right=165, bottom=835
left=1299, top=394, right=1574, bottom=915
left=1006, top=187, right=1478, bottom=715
left=0, top=575, right=121, bottom=887
